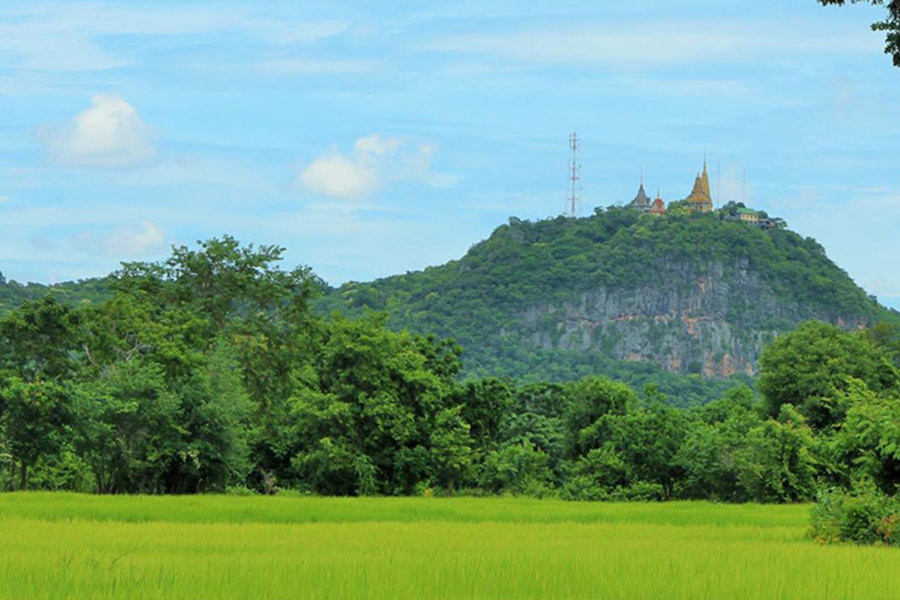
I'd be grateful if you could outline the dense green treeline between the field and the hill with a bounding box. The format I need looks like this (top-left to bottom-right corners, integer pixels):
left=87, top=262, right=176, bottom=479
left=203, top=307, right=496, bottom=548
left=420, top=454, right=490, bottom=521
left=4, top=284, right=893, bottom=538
left=0, top=237, right=900, bottom=520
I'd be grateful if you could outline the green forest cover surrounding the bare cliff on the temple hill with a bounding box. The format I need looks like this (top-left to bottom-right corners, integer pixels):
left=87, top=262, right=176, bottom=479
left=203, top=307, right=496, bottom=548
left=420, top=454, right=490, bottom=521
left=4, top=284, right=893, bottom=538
left=317, top=208, right=897, bottom=384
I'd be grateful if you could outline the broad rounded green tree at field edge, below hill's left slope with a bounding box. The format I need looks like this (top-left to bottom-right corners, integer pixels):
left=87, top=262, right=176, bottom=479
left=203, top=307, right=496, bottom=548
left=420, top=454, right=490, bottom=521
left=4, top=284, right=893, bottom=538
left=292, top=315, right=471, bottom=494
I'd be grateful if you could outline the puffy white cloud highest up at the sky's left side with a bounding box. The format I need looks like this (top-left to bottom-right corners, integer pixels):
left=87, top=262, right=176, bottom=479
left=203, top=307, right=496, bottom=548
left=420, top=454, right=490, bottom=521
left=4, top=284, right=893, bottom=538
left=43, top=94, right=156, bottom=169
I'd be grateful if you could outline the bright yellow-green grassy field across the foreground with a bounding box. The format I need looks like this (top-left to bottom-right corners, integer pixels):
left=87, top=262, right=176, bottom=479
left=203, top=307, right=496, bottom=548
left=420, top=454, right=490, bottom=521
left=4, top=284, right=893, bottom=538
left=0, top=493, right=900, bottom=600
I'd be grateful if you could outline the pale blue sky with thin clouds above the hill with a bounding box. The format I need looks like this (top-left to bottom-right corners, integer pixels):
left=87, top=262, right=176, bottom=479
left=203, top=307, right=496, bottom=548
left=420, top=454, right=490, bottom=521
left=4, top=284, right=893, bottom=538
left=0, top=0, right=900, bottom=308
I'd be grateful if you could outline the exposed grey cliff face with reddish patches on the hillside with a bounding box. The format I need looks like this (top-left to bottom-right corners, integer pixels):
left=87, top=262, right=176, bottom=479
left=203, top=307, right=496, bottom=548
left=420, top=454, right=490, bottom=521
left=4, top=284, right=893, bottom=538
left=518, top=260, right=865, bottom=377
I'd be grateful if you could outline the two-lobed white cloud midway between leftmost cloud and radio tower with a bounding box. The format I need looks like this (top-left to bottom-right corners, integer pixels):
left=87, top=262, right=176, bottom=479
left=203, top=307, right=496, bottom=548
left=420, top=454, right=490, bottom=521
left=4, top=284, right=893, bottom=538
left=299, top=134, right=434, bottom=200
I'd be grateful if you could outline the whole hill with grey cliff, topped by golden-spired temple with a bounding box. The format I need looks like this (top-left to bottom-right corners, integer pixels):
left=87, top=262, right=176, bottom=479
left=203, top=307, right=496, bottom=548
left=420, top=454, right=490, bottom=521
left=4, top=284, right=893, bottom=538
left=320, top=208, right=900, bottom=380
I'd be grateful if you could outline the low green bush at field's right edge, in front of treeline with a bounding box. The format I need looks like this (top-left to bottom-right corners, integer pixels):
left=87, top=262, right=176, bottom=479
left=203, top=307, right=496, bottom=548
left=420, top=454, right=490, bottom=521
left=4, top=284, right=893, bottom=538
left=810, top=482, right=900, bottom=546
